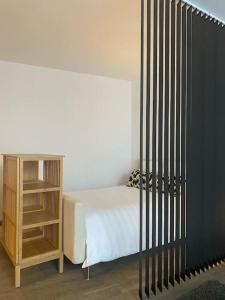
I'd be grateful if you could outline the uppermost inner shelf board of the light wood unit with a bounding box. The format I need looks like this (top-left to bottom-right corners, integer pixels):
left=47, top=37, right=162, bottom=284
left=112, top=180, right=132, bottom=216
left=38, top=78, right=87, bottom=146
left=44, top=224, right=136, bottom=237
left=23, top=180, right=60, bottom=194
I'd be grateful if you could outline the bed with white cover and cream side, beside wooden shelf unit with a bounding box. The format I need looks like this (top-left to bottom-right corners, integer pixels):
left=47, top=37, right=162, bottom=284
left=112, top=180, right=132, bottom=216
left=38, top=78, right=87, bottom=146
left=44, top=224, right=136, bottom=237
left=64, top=186, right=165, bottom=268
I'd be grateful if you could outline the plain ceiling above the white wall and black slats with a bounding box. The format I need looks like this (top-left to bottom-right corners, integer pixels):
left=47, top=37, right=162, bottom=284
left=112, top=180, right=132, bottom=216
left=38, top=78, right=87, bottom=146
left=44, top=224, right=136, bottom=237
left=0, top=0, right=225, bottom=79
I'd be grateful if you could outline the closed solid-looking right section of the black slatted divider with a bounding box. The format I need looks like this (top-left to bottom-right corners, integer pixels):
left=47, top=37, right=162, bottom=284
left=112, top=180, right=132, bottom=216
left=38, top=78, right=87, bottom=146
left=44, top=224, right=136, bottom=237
left=187, top=8, right=225, bottom=273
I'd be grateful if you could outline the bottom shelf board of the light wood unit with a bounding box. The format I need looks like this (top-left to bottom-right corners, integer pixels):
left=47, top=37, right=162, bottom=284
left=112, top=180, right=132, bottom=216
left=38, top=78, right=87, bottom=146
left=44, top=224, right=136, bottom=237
left=22, top=238, right=58, bottom=260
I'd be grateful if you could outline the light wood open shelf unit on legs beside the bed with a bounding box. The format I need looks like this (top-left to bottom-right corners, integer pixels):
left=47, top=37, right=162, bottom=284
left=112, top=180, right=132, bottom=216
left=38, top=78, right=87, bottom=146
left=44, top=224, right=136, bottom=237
left=2, top=154, right=63, bottom=287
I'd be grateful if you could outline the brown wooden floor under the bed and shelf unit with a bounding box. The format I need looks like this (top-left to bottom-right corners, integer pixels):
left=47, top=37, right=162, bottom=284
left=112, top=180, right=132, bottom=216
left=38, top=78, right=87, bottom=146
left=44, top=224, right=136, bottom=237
left=0, top=231, right=225, bottom=300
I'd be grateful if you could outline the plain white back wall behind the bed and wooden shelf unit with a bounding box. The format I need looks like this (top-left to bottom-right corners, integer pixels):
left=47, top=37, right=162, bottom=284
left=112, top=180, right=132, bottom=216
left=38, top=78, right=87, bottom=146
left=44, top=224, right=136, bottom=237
left=0, top=62, right=132, bottom=220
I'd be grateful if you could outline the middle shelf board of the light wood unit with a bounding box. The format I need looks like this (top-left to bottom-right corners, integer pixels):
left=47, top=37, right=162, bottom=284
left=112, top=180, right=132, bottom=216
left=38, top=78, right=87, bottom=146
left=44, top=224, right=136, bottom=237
left=23, top=210, right=59, bottom=229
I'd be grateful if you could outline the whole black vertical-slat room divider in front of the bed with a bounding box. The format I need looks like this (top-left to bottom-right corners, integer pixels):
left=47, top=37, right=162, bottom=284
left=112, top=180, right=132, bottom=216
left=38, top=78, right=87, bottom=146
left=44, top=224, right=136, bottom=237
left=139, top=0, right=225, bottom=298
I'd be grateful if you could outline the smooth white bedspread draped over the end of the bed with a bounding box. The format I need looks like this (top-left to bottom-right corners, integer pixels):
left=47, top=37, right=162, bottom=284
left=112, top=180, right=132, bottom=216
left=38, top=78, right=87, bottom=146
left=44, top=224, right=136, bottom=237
left=64, top=186, right=165, bottom=268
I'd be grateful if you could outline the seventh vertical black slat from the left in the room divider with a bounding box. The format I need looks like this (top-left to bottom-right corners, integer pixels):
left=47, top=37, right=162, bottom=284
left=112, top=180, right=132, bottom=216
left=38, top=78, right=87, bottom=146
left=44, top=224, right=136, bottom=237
left=175, top=1, right=182, bottom=283
